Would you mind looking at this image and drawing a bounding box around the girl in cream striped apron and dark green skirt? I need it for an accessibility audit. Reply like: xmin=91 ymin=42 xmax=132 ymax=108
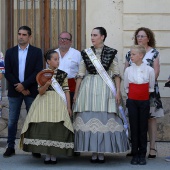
xmin=20 ymin=51 xmax=74 ymax=164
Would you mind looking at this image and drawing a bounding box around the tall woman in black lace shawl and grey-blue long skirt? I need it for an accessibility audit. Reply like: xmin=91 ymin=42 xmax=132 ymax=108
xmin=73 ymin=27 xmax=129 ymax=163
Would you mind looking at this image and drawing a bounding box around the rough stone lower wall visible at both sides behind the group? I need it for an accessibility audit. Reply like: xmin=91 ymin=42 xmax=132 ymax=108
xmin=0 ymin=91 xmax=170 ymax=141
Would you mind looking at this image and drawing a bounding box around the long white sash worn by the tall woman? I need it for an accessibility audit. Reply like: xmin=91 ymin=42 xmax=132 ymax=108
xmin=85 ymin=48 xmax=128 ymax=135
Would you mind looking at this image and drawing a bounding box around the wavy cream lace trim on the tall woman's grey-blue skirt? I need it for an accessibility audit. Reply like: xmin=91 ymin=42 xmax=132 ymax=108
xmin=73 ymin=117 xmax=124 ymax=133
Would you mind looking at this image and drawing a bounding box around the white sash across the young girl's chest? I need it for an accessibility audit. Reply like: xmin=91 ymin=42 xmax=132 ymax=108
xmin=51 ymin=77 xmax=67 ymax=105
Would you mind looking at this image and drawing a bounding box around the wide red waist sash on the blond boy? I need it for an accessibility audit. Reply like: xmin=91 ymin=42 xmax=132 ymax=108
xmin=128 ymin=83 xmax=149 ymax=100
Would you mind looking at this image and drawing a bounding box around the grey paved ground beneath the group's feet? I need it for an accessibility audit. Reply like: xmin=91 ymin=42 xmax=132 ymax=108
xmin=0 ymin=138 xmax=170 ymax=170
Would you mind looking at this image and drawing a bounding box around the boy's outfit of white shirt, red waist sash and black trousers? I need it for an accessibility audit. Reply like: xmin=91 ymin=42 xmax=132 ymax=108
xmin=124 ymin=63 xmax=155 ymax=164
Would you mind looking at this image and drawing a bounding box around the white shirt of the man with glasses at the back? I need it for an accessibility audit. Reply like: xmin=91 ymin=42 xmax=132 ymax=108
xmin=55 ymin=47 xmax=82 ymax=79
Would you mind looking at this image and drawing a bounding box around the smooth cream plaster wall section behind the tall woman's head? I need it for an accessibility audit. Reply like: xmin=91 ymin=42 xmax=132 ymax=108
xmin=86 ymin=0 xmax=123 ymax=66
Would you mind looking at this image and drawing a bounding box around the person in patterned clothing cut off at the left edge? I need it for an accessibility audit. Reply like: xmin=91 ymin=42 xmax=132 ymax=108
xmin=0 ymin=52 xmax=5 ymax=117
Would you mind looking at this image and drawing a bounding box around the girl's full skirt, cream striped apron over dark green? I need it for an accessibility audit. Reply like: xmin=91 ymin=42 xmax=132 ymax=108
xmin=20 ymin=91 xmax=74 ymax=156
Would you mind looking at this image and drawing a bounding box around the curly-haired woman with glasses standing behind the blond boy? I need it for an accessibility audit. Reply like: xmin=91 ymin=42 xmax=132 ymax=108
xmin=125 ymin=27 xmax=164 ymax=158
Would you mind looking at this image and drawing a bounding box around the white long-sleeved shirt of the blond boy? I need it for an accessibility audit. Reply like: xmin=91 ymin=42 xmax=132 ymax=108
xmin=124 ymin=63 xmax=155 ymax=93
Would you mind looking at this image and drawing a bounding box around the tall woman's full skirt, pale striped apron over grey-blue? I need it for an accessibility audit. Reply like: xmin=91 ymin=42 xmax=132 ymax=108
xmin=73 ymin=75 xmax=130 ymax=153
